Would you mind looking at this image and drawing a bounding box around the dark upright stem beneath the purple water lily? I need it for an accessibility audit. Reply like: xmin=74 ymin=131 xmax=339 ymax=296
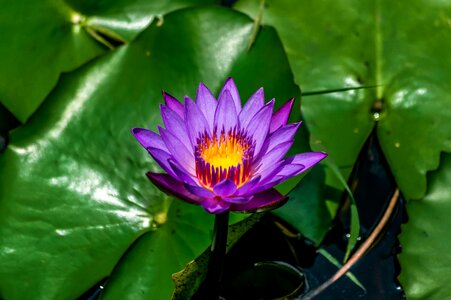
xmin=204 ymin=211 xmax=229 ymax=300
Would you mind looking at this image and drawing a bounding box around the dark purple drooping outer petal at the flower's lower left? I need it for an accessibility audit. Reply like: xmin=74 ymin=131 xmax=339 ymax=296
xmin=146 ymin=172 xmax=202 ymax=204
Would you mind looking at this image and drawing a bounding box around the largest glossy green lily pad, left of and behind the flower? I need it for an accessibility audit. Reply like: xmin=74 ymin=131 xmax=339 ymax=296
xmin=0 ymin=8 xmax=299 ymax=300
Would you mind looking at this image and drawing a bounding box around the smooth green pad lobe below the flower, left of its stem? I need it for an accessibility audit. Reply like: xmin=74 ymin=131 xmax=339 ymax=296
xmin=101 ymin=200 xmax=213 ymax=300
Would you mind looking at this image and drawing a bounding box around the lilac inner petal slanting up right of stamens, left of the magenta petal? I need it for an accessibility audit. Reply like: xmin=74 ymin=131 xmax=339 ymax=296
xmin=246 ymin=100 xmax=274 ymax=156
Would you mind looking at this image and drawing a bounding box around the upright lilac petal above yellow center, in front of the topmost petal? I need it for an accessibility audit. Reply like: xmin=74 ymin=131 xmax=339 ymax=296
xmin=214 ymin=90 xmax=238 ymax=133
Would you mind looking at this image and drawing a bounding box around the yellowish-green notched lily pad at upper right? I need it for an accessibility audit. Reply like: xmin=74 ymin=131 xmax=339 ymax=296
xmin=237 ymin=0 xmax=451 ymax=199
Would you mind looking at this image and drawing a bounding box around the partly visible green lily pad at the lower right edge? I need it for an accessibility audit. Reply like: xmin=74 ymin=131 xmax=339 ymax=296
xmin=399 ymin=154 xmax=451 ymax=300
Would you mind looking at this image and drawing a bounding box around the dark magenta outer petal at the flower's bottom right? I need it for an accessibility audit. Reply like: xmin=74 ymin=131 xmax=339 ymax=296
xmin=230 ymin=189 xmax=288 ymax=212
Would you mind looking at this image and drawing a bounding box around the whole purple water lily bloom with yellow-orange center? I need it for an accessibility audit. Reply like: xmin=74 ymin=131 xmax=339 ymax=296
xmin=132 ymin=78 xmax=327 ymax=214
